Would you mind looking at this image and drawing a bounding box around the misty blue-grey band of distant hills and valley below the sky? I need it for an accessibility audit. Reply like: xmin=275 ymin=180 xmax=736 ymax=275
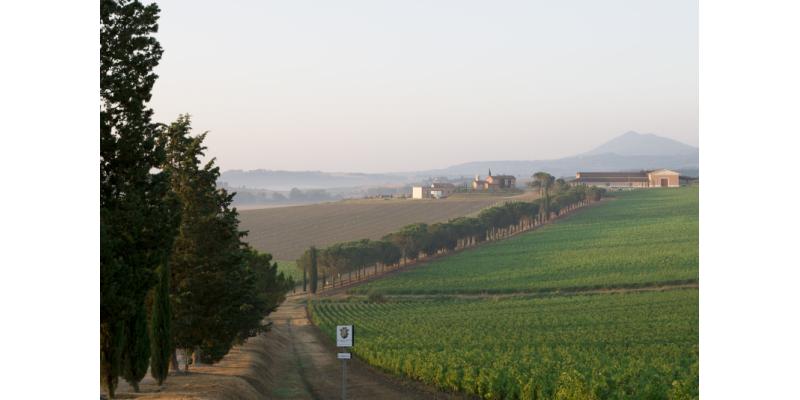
xmin=219 ymin=131 xmax=699 ymax=204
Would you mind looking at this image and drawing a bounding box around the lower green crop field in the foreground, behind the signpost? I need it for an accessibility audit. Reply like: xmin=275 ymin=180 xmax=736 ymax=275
xmin=312 ymin=289 xmax=699 ymax=399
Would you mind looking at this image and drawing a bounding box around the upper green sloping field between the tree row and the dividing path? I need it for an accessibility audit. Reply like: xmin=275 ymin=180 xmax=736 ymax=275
xmin=353 ymin=187 xmax=699 ymax=294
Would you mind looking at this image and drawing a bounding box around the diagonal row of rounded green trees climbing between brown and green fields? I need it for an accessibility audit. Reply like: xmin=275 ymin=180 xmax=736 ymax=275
xmin=297 ymin=177 xmax=605 ymax=293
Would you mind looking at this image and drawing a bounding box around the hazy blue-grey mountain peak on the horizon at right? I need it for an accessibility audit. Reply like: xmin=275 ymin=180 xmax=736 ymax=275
xmin=582 ymin=131 xmax=698 ymax=156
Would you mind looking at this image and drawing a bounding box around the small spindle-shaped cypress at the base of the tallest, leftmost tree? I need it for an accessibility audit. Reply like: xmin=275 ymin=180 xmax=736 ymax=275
xmin=122 ymin=302 xmax=150 ymax=392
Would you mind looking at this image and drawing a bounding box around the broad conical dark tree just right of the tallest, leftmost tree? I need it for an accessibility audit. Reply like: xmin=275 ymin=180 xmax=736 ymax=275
xmin=164 ymin=115 xmax=284 ymax=366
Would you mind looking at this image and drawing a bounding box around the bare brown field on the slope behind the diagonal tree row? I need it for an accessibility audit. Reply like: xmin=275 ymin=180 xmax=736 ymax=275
xmin=239 ymin=193 xmax=535 ymax=260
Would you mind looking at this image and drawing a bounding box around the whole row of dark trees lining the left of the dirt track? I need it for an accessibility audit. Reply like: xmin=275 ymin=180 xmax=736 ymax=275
xmin=100 ymin=0 xmax=294 ymax=398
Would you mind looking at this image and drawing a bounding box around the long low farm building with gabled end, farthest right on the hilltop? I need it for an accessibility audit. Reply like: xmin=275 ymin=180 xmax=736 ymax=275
xmin=573 ymin=169 xmax=680 ymax=189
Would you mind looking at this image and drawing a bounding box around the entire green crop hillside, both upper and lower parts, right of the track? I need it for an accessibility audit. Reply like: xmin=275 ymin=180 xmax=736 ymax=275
xmin=309 ymin=187 xmax=699 ymax=399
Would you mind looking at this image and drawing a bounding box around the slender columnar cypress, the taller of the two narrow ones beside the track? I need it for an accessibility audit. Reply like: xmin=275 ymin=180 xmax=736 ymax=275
xmin=150 ymin=263 xmax=173 ymax=386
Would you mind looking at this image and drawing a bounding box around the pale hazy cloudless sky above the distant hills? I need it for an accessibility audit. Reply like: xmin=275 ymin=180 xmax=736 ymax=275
xmin=152 ymin=0 xmax=698 ymax=172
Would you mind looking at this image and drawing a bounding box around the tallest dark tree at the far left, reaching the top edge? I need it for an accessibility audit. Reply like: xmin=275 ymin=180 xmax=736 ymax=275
xmin=100 ymin=0 xmax=175 ymax=397
